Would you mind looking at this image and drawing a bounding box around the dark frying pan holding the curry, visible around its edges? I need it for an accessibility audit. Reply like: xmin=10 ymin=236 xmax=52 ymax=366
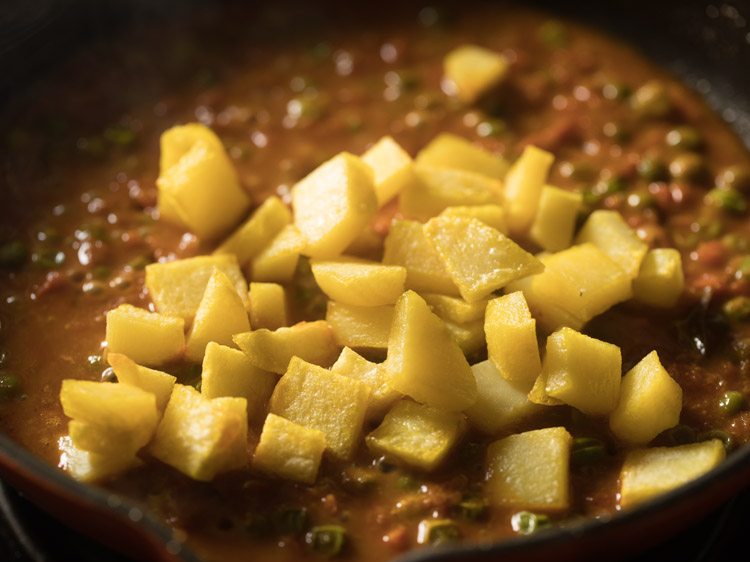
xmin=0 ymin=0 xmax=750 ymax=562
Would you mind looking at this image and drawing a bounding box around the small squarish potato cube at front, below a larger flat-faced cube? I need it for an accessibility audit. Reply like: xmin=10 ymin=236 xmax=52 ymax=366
xmin=252 ymin=414 xmax=326 ymax=484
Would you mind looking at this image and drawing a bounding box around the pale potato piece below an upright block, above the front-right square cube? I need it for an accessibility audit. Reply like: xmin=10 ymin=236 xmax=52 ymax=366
xmin=465 ymin=360 xmax=540 ymax=435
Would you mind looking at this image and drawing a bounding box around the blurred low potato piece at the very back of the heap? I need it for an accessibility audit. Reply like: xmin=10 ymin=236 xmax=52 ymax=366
xmin=415 ymin=133 xmax=510 ymax=180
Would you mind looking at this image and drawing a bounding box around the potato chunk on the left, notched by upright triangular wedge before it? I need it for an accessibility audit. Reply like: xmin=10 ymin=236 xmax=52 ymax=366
xmin=146 ymin=254 xmax=247 ymax=320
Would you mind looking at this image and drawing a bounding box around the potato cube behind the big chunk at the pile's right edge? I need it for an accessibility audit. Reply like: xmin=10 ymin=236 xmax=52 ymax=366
xmin=576 ymin=209 xmax=648 ymax=279
